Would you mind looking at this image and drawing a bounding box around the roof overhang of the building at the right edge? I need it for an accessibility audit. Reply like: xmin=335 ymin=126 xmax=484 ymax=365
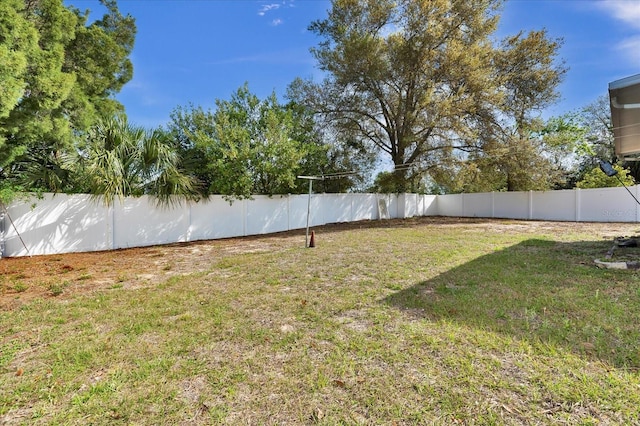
xmin=609 ymin=74 xmax=640 ymax=160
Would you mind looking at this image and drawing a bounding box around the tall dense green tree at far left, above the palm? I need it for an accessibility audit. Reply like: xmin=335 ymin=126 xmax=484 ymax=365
xmin=0 ymin=0 xmax=135 ymax=198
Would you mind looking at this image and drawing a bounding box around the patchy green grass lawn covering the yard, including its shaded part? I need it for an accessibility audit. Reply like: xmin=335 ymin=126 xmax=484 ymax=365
xmin=0 ymin=219 xmax=640 ymax=425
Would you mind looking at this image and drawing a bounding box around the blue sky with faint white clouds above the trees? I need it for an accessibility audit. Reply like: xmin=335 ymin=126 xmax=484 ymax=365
xmin=66 ymin=0 xmax=640 ymax=127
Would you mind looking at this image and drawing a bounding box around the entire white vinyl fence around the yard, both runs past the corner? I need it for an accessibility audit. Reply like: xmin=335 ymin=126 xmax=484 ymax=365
xmin=0 ymin=186 xmax=640 ymax=257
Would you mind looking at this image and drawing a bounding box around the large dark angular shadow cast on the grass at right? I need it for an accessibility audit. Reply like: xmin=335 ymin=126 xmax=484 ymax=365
xmin=385 ymin=239 xmax=640 ymax=369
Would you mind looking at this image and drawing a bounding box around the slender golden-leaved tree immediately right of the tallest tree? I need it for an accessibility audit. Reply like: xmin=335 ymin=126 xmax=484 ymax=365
xmin=472 ymin=31 xmax=573 ymax=191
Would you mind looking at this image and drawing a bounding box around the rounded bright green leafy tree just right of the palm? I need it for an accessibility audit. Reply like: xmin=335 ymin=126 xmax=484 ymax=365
xmin=169 ymin=84 xmax=307 ymax=199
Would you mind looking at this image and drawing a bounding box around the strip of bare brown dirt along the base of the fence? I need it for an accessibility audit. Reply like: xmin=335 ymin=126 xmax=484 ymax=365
xmin=0 ymin=217 xmax=639 ymax=310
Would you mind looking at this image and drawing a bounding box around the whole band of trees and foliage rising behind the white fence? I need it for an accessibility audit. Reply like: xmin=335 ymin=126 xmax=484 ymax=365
xmin=0 ymin=0 xmax=640 ymax=203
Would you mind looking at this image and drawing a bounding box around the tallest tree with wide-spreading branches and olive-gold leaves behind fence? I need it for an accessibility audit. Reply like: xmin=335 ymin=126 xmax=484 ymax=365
xmin=306 ymin=0 xmax=557 ymax=191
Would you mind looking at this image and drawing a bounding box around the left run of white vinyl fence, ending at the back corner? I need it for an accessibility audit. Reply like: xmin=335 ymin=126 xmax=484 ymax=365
xmin=0 ymin=194 xmax=437 ymax=257
